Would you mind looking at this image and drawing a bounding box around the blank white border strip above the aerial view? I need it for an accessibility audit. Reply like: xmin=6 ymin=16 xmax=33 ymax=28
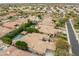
xmin=0 ymin=0 xmax=79 ymax=3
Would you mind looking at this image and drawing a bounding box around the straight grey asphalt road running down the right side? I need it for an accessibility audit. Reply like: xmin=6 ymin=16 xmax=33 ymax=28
xmin=67 ymin=21 xmax=79 ymax=56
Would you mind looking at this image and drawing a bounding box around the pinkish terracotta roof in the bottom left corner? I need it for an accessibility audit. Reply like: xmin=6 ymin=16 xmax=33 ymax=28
xmin=0 ymin=46 xmax=32 ymax=56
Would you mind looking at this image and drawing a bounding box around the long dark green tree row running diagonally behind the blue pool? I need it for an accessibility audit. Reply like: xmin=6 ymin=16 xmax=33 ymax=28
xmin=1 ymin=22 xmax=39 ymax=44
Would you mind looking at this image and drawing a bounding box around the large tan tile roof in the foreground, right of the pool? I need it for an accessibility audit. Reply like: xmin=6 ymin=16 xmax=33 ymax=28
xmin=21 ymin=33 xmax=55 ymax=54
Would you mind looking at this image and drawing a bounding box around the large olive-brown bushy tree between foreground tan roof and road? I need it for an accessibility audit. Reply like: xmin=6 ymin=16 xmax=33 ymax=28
xmin=55 ymin=39 xmax=69 ymax=56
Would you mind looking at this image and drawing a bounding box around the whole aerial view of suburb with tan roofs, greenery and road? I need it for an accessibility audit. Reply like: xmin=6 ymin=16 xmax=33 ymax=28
xmin=0 ymin=3 xmax=79 ymax=56
